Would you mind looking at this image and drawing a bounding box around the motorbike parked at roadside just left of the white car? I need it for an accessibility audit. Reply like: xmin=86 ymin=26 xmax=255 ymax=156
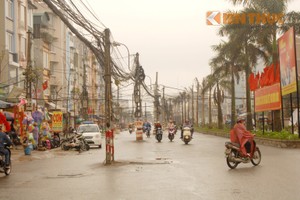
xmin=60 ymin=133 xmax=90 ymax=153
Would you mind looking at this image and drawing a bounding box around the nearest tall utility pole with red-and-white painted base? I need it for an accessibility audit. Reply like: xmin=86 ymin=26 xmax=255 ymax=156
xmin=104 ymin=29 xmax=113 ymax=164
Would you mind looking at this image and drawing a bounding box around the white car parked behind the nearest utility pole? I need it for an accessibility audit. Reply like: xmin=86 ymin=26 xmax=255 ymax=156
xmin=77 ymin=124 xmax=102 ymax=148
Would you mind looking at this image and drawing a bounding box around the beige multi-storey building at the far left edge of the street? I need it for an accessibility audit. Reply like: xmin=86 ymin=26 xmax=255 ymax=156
xmin=0 ymin=0 xmax=36 ymax=102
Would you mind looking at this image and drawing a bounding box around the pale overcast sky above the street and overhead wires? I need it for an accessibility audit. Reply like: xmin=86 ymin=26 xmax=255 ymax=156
xmin=84 ymin=0 xmax=300 ymax=96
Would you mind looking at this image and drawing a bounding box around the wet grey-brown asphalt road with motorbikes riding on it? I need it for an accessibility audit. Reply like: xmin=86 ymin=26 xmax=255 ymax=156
xmin=0 ymin=132 xmax=300 ymax=200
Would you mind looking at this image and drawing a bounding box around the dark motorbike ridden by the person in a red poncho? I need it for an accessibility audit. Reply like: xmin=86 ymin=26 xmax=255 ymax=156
xmin=225 ymin=142 xmax=261 ymax=169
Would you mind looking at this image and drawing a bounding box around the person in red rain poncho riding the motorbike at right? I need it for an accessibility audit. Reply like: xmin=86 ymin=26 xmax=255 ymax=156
xmin=230 ymin=117 xmax=255 ymax=157
